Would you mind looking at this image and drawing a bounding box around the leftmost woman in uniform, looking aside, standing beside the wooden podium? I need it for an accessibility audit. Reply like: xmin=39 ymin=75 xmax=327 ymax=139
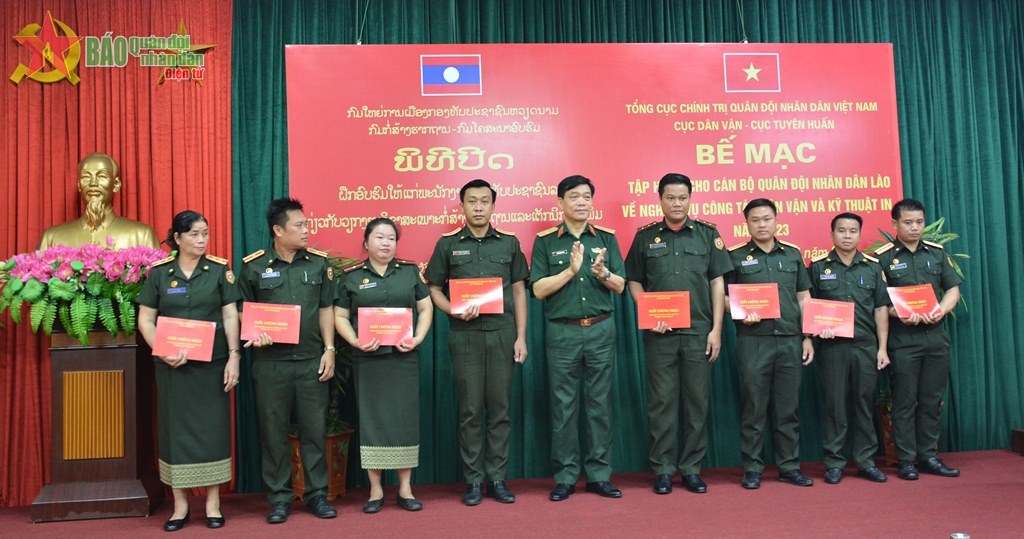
xmin=136 ymin=210 xmax=242 ymax=532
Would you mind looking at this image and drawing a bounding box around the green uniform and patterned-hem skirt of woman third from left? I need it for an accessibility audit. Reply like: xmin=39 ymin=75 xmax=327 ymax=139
xmin=335 ymin=260 xmax=430 ymax=469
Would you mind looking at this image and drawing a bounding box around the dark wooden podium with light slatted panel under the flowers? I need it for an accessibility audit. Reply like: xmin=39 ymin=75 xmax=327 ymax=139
xmin=32 ymin=331 xmax=164 ymax=523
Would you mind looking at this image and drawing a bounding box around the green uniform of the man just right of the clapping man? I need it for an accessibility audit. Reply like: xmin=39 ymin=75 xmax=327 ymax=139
xmin=626 ymin=218 xmax=732 ymax=475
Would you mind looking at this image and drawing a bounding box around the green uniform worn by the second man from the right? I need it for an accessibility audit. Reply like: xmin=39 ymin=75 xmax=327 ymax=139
xmin=808 ymin=249 xmax=889 ymax=470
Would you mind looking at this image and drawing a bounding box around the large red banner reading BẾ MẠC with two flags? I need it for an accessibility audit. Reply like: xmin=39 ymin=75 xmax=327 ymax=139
xmin=286 ymin=44 xmax=902 ymax=261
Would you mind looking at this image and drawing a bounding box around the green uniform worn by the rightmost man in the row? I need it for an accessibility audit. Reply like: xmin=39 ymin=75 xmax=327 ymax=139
xmin=874 ymin=240 xmax=961 ymax=462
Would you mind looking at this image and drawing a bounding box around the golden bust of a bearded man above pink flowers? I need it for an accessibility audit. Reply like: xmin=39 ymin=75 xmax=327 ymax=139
xmin=39 ymin=153 xmax=160 ymax=249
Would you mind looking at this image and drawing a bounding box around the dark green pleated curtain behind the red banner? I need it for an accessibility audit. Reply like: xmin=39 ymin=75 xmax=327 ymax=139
xmin=232 ymin=0 xmax=1024 ymax=491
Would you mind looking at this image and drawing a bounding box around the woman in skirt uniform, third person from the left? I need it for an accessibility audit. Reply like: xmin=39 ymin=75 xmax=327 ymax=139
xmin=334 ymin=217 xmax=434 ymax=513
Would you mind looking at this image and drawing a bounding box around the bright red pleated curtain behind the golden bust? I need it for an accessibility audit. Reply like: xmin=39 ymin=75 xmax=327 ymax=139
xmin=0 ymin=0 xmax=231 ymax=506
